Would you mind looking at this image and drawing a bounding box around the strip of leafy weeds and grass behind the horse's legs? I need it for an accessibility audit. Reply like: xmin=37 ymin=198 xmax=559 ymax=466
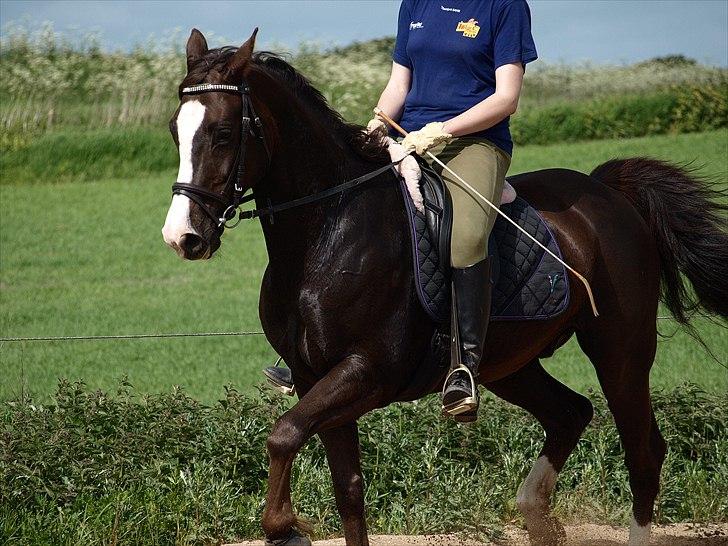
xmin=0 ymin=382 xmax=728 ymax=544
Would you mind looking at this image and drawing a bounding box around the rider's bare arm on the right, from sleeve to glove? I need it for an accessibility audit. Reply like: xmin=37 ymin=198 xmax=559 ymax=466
xmin=443 ymin=63 xmax=523 ymax=137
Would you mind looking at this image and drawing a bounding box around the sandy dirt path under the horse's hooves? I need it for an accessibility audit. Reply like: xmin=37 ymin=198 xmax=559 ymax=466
xmin=228 ymin=523 xmax=728 ymax=546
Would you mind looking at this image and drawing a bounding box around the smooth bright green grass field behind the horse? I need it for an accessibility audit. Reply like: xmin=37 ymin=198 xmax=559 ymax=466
xmin=0 ymin=126 xmax=728 ymax=402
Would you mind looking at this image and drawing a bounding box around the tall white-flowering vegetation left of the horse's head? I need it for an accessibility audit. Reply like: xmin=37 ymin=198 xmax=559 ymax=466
xmin=0 ymin=25 xmax=185 ymax=137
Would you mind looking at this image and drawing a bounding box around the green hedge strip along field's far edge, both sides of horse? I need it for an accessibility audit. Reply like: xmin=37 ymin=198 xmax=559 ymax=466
xmin=0 ymin=83 xmax=728 ymax=183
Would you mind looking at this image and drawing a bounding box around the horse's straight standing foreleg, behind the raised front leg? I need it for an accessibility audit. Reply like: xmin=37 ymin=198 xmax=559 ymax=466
xmin=319 ymin=423 xmax=369 ymax=546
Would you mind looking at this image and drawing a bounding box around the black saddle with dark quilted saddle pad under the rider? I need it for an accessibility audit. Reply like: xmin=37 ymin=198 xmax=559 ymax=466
xmin=400 ymin=156 xmax=569 ymax=323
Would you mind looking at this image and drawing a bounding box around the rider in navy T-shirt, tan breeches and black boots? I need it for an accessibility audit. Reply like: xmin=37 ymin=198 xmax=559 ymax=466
xmin=266 ymin=0 xmax=537 ymax=422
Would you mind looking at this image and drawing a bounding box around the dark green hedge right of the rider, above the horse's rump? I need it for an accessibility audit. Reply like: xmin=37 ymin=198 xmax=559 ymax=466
xmin=511 ymin=84 xmax=728 ymax=144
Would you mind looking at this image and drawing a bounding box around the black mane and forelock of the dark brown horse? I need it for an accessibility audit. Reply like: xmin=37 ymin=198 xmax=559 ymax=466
xmin=180 ymin=46 xmax=388 ymax=161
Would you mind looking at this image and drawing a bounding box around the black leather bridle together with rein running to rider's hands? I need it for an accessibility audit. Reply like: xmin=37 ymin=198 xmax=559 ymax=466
xmin=172 ymin=82 xmax=402 ymax=231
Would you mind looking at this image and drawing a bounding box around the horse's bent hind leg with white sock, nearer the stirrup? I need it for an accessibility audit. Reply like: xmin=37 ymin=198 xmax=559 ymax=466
xmin=485 ymin=360 xmax=593 ymax=546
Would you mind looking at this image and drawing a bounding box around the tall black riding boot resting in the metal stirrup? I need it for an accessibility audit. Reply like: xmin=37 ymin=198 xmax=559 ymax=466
xmin=442 ymin=257 xmax=491 ymax=423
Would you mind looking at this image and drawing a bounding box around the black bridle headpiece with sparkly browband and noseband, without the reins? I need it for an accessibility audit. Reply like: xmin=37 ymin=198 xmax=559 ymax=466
xmin=172 ymin=82 xmax=270 ymax=230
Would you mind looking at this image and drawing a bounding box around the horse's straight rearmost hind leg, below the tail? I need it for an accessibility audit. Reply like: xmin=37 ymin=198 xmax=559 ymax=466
xmin=577 ymin=317 xmax=666 ymax=546
